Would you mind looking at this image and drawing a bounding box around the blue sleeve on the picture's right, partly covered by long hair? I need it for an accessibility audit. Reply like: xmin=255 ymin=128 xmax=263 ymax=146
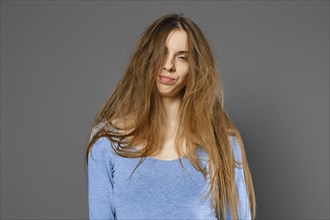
xmin=227 ymin=137 xmax=251 ymax=220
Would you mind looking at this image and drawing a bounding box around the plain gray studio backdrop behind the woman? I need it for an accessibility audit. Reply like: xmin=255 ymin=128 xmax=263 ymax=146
xmin=1 ymin=1 xmax=329 ymax=219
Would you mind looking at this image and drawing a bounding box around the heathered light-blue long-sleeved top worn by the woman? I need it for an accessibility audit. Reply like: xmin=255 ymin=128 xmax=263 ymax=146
xmin=88 ymin=125 xmax=251 ymax=219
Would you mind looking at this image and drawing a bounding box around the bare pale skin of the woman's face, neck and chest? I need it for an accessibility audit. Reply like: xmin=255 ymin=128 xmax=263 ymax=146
xmin=112 ymin=29 xmax=189 ymax=160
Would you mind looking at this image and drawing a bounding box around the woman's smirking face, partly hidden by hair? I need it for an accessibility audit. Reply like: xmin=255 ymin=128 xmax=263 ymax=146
xmin=157 ymin=30 xmax=189 ymax=98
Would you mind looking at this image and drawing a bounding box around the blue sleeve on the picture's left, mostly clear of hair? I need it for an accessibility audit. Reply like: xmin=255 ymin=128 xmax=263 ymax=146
xmin=88 ymin=137 xmax=116 ymax=220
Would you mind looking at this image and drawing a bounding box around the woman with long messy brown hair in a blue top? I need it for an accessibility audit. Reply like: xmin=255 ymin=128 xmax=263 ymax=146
xmin=85 ymin=13 xmax=256 ymax=219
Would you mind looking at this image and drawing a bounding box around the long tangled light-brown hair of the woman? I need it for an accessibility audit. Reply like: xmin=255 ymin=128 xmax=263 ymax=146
xmin=85 ymin=12 xmax=256 ymax=219
